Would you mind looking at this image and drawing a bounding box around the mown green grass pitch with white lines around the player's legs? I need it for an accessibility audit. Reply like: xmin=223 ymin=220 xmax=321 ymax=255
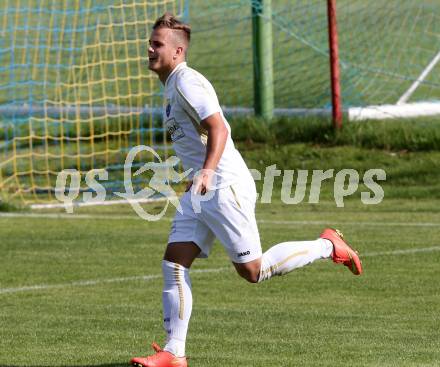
xmin=0 ymin=145 xmax=440 ymax=367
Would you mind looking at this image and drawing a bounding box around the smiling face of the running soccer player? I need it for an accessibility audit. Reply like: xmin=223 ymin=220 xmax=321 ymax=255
xmin=148 ymin=28 xmax=177 ymax=76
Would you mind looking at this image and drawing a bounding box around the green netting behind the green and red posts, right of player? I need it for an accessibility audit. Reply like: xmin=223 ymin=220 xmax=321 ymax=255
xmin=189 ymin=0 xmax=440 ymax=118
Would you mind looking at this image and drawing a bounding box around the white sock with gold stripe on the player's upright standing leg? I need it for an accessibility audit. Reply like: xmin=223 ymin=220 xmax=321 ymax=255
xmin=162 ymin=260 xmax=192 ymax=357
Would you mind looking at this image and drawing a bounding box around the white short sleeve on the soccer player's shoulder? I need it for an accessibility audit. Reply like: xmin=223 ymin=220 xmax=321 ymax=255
xmin=176 ymin=73 xmax=221 ymax=124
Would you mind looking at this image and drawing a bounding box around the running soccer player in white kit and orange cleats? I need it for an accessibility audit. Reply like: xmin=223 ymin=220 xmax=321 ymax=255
xmin=131 ymin=13 xmax=362 ymax=367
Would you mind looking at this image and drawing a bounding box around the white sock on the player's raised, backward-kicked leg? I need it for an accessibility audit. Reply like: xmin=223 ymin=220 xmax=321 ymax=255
xmin=258 ymin=238 xmax=333 ymax=282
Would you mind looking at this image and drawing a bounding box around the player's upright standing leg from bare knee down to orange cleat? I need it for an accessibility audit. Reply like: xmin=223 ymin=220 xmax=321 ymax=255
xmin=131 ymin=242 xmax=200 ymax=367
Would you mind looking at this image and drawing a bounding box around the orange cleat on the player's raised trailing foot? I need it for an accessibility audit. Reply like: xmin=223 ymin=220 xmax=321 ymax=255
xmin=319 ymin=228 xmax=362 ymax=275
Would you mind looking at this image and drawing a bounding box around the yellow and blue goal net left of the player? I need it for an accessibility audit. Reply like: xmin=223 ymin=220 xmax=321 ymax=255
xmin=0 ymin=0 xmax=185 ymax=204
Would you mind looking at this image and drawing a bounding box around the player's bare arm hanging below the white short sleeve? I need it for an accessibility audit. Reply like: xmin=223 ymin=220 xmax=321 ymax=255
xmin=193 ymin=112 xmax=229 ymax=195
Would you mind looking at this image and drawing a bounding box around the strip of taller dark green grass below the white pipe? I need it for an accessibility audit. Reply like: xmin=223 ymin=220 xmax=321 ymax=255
xmin=230 ymin=117 xmax=440 ymax=151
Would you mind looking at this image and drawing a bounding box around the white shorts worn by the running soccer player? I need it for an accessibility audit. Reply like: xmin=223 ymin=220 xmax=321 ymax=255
xmin=168 ymin=182 xmax=262 ymax=263
